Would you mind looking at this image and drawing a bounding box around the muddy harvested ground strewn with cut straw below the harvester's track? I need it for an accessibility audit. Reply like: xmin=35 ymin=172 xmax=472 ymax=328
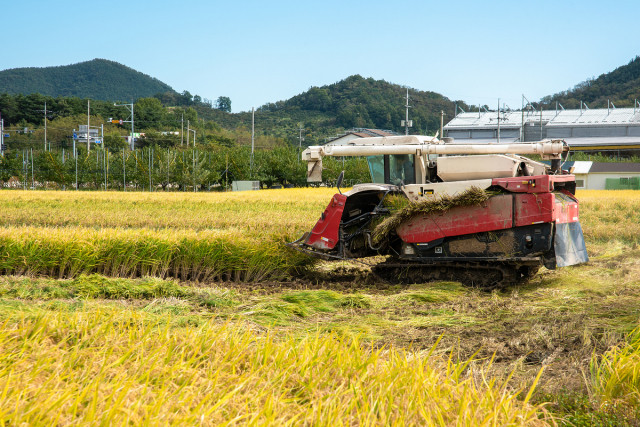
xmin=214 ymin=245 xmax=640 ymax=422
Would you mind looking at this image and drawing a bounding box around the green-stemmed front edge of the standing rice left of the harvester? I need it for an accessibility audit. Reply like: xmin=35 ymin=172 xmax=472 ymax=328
xmin=0 ymin=227 xmax=312 ymax=282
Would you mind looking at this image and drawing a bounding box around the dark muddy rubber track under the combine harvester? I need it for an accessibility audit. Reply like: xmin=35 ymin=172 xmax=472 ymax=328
xmin=372 ymin=260 xmax=539 ymax=290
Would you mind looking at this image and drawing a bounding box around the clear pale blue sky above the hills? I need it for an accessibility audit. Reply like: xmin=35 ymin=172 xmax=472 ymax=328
xmin=0 ymin=0 xmax=640 ymax=112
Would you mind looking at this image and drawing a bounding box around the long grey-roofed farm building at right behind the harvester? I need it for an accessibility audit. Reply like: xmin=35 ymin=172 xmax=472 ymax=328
xmin=444 ymin=102 xmax=640 ymax=153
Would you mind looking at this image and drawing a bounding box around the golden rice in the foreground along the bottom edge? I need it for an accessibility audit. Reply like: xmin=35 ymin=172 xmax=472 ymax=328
xmin=0 ymin=310 xmax=553 ymax=426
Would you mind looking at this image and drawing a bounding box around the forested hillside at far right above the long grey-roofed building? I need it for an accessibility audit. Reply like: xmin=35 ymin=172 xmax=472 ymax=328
xmin=541 ymin=56 xmax=640 ymax=108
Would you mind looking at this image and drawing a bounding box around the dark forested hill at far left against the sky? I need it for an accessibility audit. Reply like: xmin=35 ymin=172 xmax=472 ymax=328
xmin=0 ymin=59 xmax=173 ymax=101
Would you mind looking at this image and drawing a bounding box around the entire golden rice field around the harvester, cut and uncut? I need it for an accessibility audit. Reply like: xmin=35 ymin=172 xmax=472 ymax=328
xmin=0 ymin=189 xmax=640 ymax=426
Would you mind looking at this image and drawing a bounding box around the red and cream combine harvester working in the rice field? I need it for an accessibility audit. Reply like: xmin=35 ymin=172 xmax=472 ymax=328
xmin=290 ymin=135 xmax=588 ymax=289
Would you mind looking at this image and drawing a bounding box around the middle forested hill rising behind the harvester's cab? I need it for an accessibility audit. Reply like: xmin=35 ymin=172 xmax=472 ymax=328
xmin=189 ymin=75 xmax=468 ymax=145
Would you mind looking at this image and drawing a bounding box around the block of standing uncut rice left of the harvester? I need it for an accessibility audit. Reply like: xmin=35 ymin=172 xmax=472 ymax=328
xmin=0 ymin=189 xmax=332 ymax=282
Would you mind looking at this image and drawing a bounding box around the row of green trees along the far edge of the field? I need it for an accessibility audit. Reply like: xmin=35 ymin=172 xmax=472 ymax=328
xmin=0 ymin=146 xmax=370 ymax=191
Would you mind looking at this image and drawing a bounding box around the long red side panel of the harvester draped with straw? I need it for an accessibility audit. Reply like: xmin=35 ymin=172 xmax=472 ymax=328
xmin=396 ymin=194 xmax=513 ymax=243
